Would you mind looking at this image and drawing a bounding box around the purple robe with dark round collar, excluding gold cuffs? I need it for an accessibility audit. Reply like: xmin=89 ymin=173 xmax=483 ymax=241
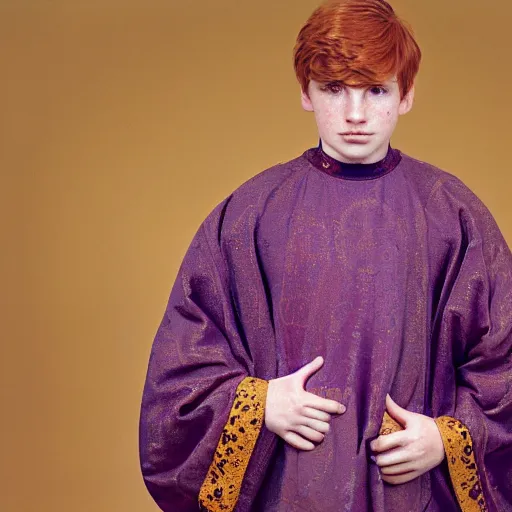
xmin=140 ymin=148 xmax=512 ymax=512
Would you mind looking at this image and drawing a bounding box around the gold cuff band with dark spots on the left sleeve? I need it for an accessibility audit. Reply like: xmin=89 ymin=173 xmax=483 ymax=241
xmin=199 ymin=377 xmax=268 ymax=512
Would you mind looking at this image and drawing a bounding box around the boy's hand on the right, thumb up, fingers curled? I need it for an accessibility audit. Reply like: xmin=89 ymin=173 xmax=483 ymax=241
xmin=370 ymin=395 xmax=445 ymax=485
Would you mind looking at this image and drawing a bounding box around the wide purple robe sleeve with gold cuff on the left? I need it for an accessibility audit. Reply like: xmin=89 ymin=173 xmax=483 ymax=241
xmin=139 ymin=203 xmax=273 ymax=512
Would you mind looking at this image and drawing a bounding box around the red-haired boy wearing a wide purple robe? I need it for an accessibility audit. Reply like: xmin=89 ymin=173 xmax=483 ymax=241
xmin=141 ymin=0 xmax=512 ymax=512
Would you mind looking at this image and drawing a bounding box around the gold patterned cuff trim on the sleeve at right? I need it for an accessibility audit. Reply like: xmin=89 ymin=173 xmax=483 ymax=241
xmin=435 ymin=416 xmax=488 ymax=512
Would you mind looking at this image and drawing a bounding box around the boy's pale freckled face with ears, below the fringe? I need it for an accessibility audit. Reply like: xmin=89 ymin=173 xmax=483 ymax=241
xmin=301 ymin=78 xmax=414 ymax=164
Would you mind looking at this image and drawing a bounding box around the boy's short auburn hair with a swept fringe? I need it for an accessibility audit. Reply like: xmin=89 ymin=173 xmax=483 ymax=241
xmin=293 ymin=0 xmax=421 ymax=98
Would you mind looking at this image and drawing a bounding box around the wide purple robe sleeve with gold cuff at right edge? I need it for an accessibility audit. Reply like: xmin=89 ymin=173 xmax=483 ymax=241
xmin=429 ymin=179 xmax=512 ymax=512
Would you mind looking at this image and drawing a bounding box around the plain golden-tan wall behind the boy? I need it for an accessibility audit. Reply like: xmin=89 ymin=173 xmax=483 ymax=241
xmin=0 ymin=0 xmax=512 ymax=512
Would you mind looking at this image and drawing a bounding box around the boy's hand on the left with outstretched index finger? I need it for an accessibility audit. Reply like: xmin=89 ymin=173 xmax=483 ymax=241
xmin=265 ymin=357 xmax=346 ymax=450
